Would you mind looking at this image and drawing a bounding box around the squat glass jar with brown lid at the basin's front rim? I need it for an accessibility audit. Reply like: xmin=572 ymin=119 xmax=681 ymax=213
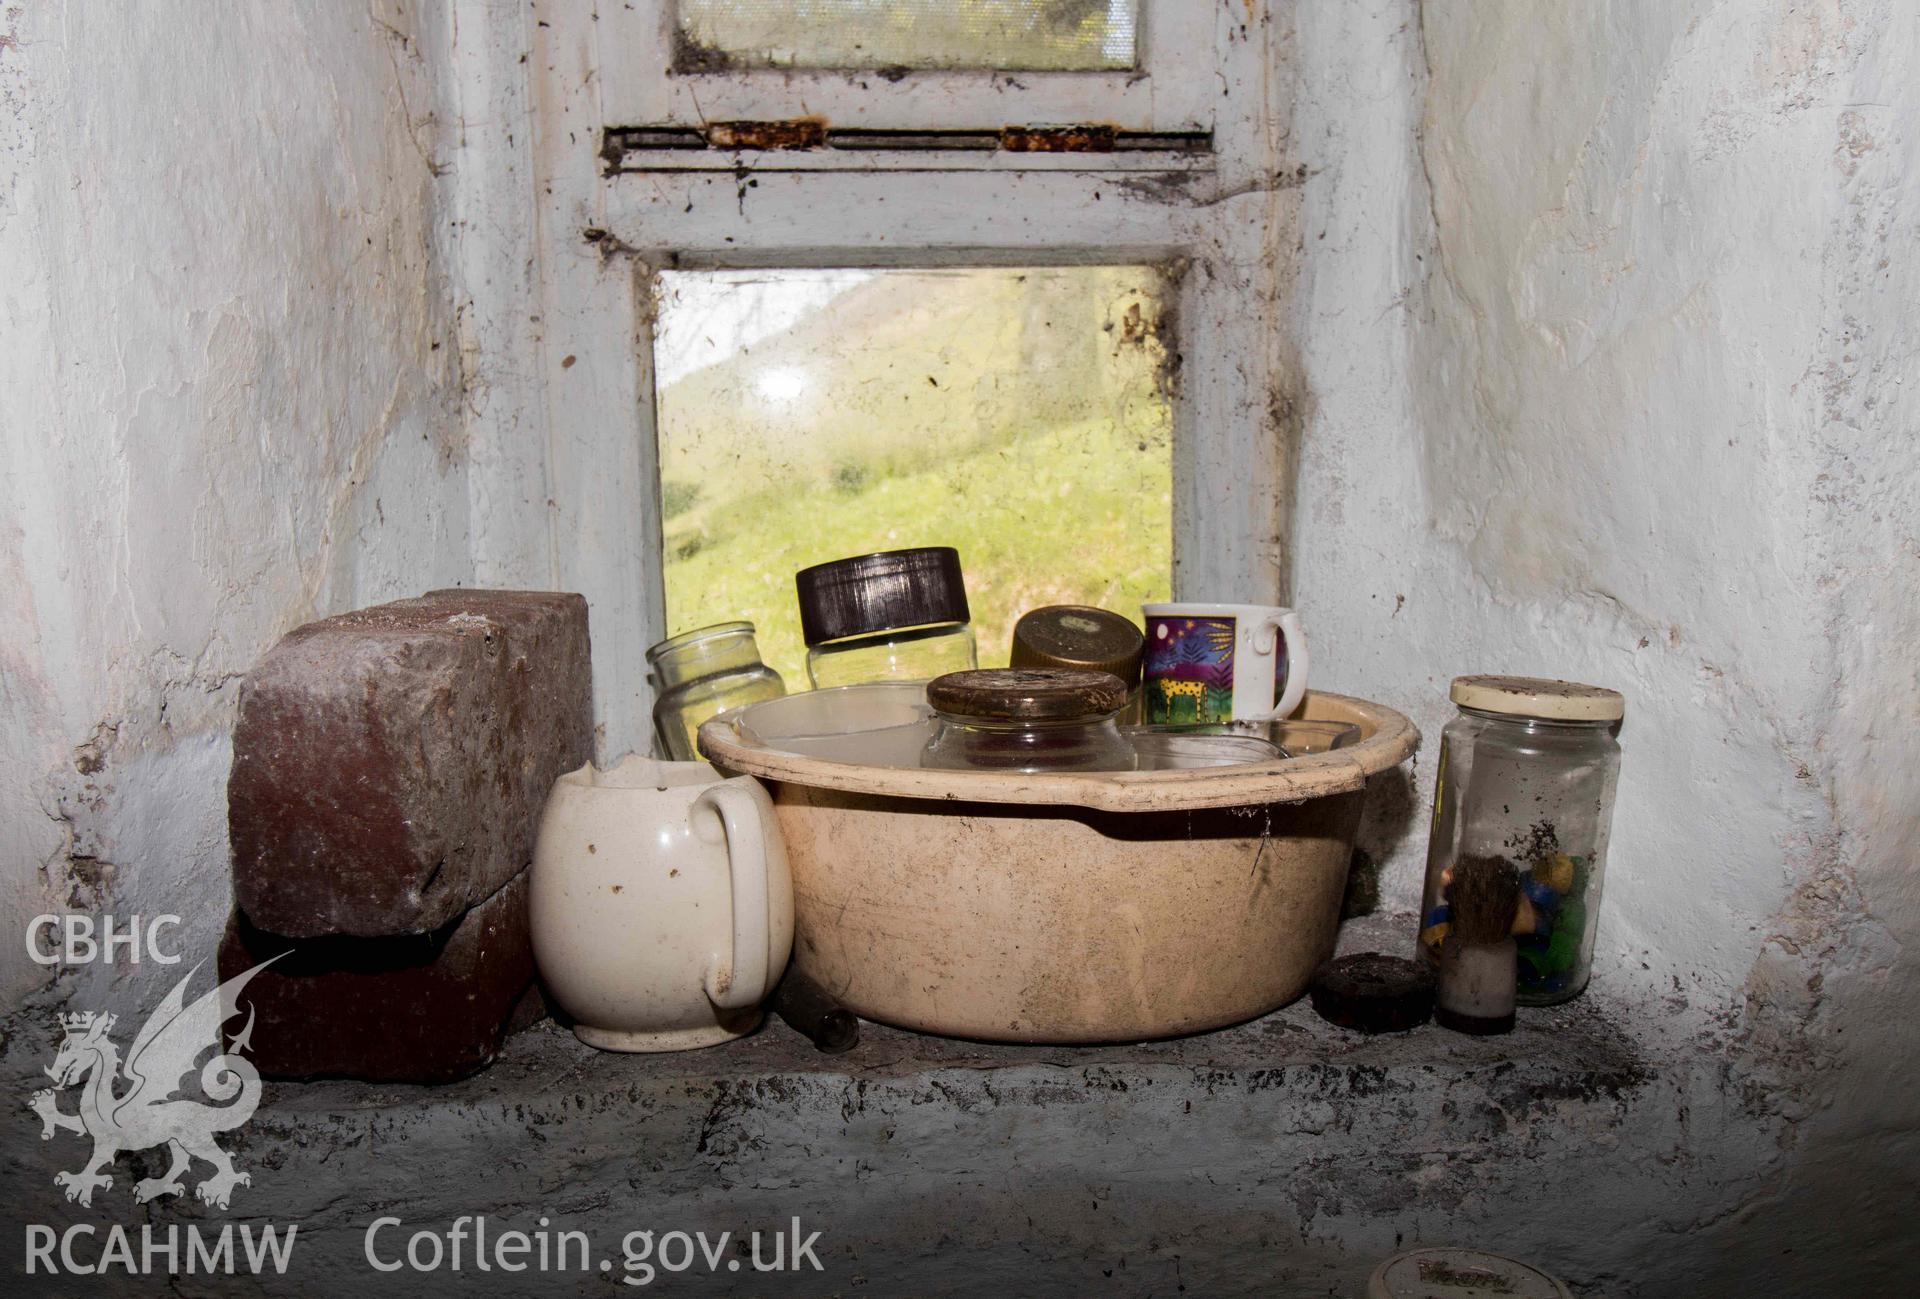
xmin=920 ymin=668 xmax=1135 ymax=771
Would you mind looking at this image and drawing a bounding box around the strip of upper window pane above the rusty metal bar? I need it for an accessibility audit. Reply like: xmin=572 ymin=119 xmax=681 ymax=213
xmin=674 ymin=0 xmax=1136 ymax=71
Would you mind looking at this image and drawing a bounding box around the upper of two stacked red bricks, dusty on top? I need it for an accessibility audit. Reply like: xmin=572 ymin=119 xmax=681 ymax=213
xmin=227 ymin=591 xmax=593 ymax=938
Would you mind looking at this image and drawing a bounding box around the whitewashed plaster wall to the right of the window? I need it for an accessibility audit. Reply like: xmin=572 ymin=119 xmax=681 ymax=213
xmin=1294 ymin=0 xmax=1920 ymax=1293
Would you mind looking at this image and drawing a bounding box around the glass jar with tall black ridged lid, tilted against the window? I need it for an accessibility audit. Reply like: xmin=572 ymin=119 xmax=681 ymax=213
xmin=793 ymin=545 xmax=979 ymax=691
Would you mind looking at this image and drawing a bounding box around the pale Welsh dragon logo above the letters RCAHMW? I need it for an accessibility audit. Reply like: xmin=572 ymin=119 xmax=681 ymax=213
xmin=29 ymin=961 xmax=271 ymax=1209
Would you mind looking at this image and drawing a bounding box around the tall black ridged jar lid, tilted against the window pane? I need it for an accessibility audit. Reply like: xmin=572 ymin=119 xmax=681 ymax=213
xmin=793 ymin=545 xmax=972 ymax=649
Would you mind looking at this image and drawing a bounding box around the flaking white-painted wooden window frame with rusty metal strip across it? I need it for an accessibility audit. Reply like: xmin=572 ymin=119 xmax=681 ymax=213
xmin=495 ymin=0 xmax=1300 ymax=756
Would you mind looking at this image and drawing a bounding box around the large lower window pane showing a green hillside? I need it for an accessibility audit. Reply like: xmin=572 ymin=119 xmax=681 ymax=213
xmin=655 ymin=267 xmax=1173 ymax=689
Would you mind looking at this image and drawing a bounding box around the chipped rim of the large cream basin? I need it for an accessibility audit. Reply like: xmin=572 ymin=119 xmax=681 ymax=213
xmin=699 ymin=691 xmax=1421 ymax=812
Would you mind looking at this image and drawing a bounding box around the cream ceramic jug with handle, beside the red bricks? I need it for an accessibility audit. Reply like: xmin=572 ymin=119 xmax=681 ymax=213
xmin=528 ymin=756 xmax=793 ymax=1051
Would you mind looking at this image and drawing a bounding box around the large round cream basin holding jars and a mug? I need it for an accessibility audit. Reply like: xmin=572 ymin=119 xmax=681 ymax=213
xmin=701 ymin=683 xmax=1419 ymax=1042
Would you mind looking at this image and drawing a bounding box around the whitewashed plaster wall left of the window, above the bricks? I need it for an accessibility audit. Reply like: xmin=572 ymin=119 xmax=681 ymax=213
xmin=0 ymin=0 xmax=472 ymax=1004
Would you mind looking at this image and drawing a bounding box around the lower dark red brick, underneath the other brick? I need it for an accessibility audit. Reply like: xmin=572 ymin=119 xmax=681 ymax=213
xmin=219 ymin=871 xmax=534 ymax=1082
